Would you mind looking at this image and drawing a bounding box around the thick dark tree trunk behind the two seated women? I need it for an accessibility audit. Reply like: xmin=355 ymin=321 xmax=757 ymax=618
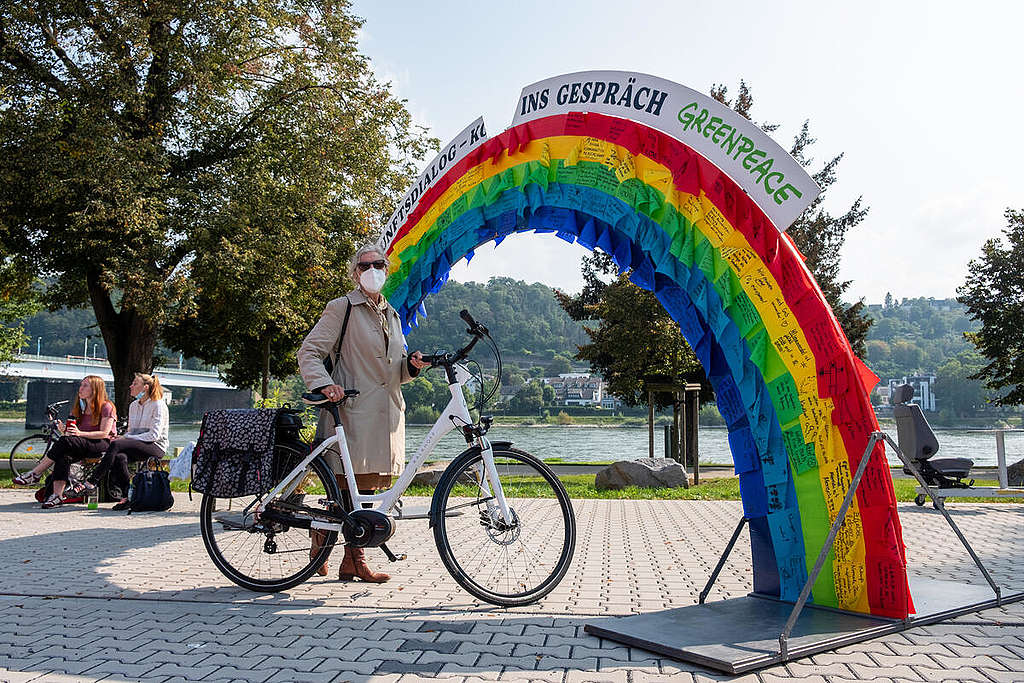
xmin=86 ymin=273 xmax=157 ymax=416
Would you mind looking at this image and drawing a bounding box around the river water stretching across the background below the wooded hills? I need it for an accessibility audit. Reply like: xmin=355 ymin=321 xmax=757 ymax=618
xmin=0 ymin=422 xmax=1024 ymax=465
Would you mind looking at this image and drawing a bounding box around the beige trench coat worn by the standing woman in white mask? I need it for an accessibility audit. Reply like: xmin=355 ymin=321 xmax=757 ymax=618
xmin=298 ymin=288 xmax=418 ymax=475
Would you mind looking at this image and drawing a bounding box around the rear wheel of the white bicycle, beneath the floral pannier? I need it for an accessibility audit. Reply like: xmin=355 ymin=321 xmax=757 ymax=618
xmin=200 ymin=446 xmax=341 ymax=593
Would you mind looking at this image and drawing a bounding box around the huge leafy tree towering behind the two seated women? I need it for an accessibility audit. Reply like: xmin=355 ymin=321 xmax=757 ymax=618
xmin=0 ymin=0 xmax=432 ymax=410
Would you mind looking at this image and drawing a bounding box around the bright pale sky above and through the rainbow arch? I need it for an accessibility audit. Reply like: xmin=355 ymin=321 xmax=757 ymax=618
xmin=354 ymin=0 xmax=1024 ymax=303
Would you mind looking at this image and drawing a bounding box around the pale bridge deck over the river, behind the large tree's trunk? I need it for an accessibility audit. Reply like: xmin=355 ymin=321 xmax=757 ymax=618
xmin=0 ymin=354 xmax=234 ymax=389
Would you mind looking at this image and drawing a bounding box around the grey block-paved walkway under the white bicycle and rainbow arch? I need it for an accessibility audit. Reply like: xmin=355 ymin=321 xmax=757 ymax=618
xmin=0 ymin=490 xmax=1024 ymax=683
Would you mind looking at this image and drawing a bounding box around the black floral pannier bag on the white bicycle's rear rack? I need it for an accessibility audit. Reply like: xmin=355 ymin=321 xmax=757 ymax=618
xmin=190 ymin=409 xmax=278 ymax=498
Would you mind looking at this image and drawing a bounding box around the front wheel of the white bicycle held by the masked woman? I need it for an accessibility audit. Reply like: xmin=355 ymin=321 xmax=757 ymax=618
xmin=434 ymin=447 xmax=575 ymax=607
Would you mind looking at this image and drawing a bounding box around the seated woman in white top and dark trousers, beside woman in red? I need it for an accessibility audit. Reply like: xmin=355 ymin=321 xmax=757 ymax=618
xmin=74 ymin=373 xmax=167 ymax=510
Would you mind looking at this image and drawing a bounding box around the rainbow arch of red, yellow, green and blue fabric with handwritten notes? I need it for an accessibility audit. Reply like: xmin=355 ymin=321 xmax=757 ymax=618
xmin=385 ymin=105 xmax=913 ymax=618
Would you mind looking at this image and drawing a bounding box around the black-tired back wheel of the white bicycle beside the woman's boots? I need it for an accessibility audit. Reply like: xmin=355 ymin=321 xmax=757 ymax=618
xmin=200 ymin=446 xmax=341 ymax=593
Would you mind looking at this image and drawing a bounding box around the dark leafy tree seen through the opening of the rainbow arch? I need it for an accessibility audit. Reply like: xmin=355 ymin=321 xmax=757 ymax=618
xmin=555 ymin=251 xmax=710 ymax=407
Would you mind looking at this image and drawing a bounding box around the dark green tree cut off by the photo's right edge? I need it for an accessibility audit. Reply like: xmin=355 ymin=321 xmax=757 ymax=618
xmin=956 ymin=209 xmax=1024 ymax=405
